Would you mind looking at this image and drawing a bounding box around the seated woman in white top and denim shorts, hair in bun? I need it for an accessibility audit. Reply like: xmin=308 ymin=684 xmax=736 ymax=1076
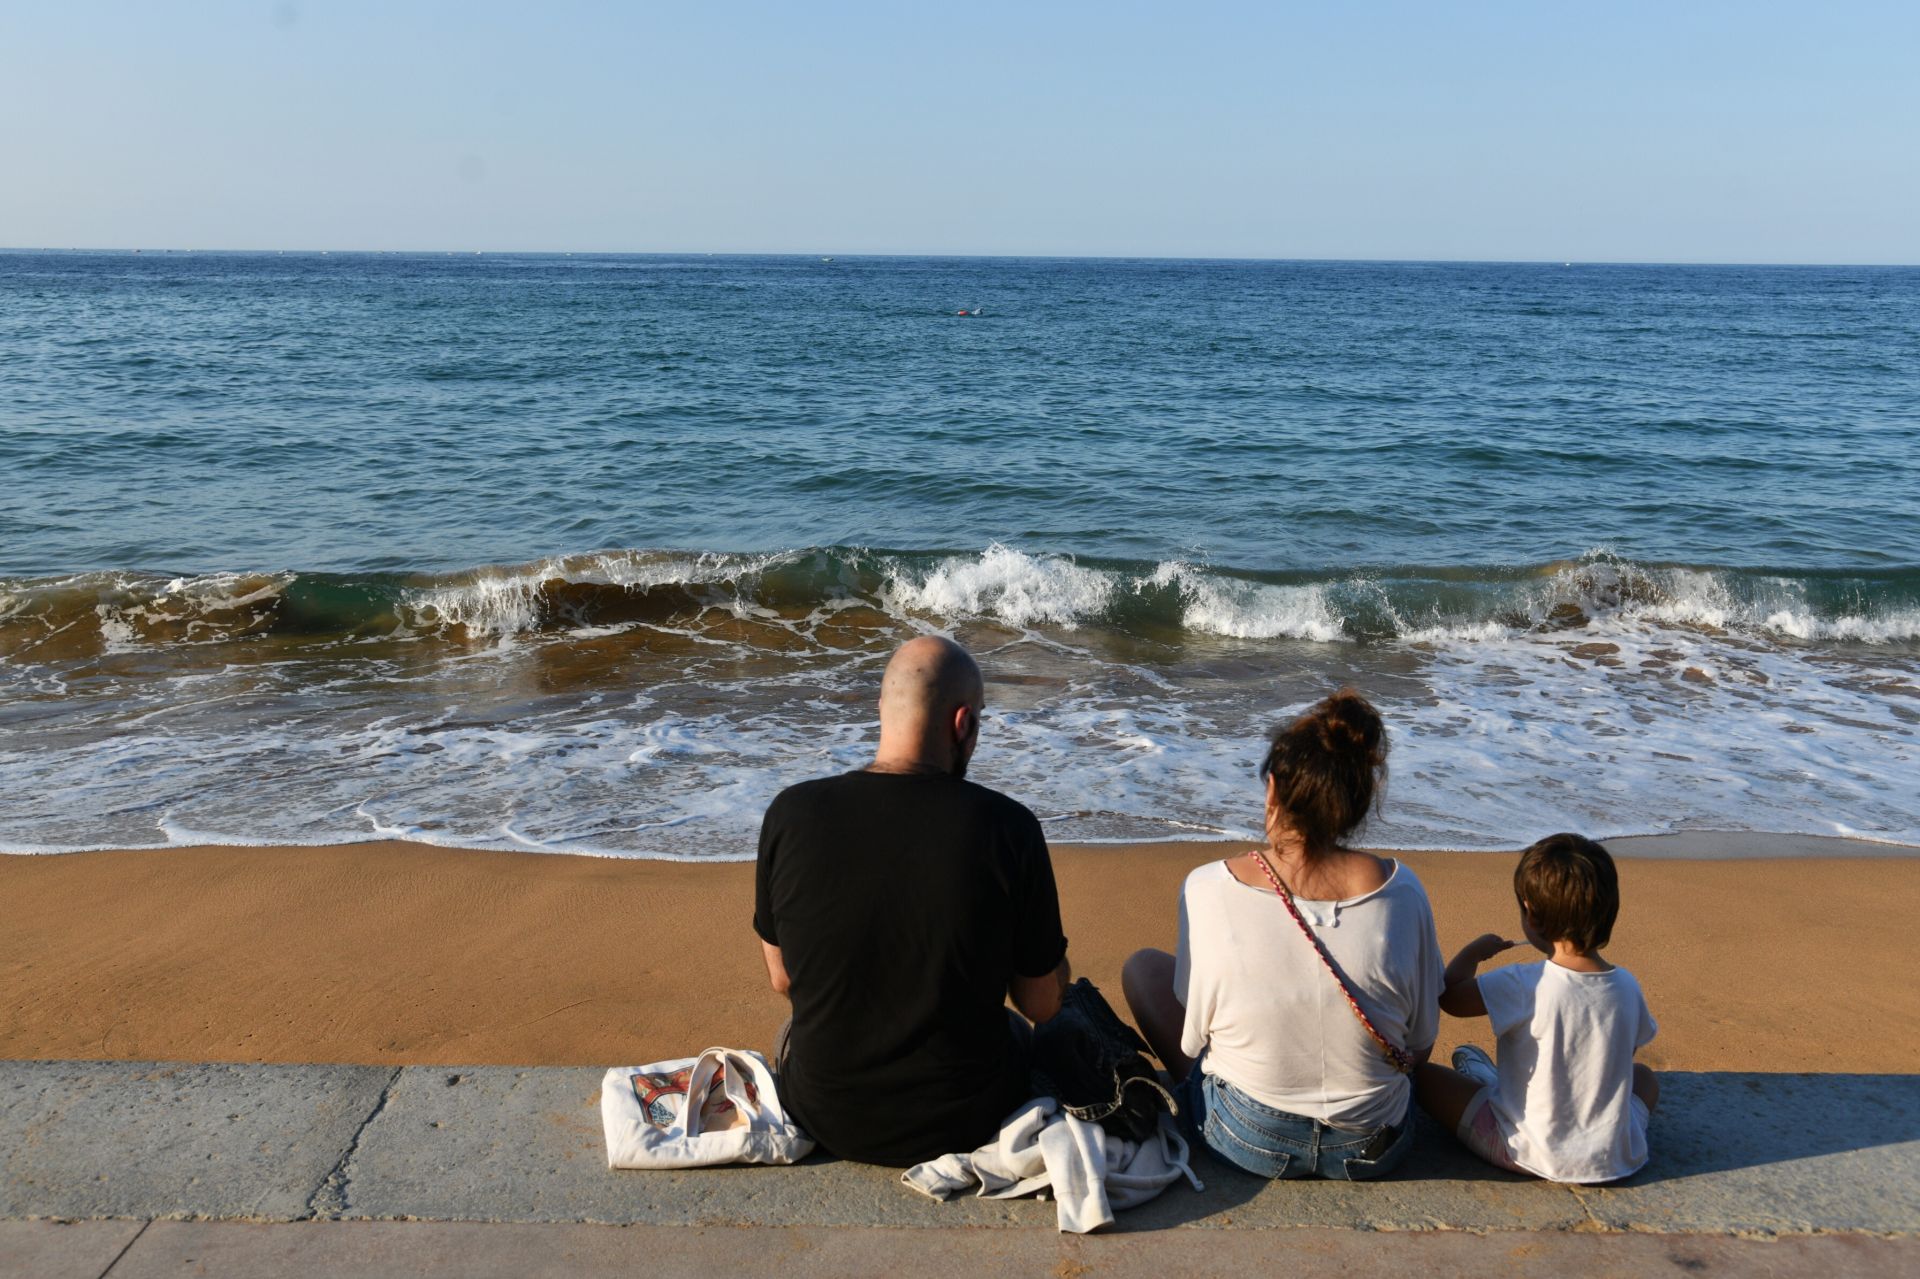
xmin=1121 ymin=689 xmax=1444 ymax=1181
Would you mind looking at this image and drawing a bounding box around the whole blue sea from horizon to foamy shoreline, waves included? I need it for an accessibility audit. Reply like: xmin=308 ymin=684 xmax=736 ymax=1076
xmin=0 ymin=250 xmax=1920 ymax=858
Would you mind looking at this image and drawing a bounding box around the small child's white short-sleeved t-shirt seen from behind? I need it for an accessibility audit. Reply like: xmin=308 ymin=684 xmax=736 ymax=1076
xmin=1480 ymin=960 xmax=1657 ymax=1181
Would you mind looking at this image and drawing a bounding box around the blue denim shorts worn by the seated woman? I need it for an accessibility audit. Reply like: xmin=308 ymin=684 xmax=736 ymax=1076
xmin=1177 ymin=1062 xmax=1413 ymax=1181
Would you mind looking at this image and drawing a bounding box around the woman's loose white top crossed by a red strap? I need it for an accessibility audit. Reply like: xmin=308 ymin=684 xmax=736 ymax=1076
xmin=1173 ymin=862 xmax=1446 ymax=1129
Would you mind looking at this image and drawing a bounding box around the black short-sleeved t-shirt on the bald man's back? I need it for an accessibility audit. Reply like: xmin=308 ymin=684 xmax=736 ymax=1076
xmin=753 ymin=772 xmax=1068 ymax=1166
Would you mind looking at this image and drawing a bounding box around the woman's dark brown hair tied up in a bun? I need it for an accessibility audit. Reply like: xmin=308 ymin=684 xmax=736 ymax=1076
xmin=1260 ymin=688 xmax=1386 ymax=855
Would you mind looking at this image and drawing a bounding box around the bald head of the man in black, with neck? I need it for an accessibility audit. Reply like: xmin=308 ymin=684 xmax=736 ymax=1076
xmin=874 ymin=636 xmax=987 ymax=778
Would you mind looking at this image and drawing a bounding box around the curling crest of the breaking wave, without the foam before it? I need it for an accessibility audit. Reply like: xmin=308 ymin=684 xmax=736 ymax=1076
xmin=0 ymin=543 xmax=1920 ymax=661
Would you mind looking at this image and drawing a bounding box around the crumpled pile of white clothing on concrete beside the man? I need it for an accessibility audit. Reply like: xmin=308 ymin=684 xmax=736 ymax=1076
xmin=900 ymin=1097 xmax=1206 ymax=1235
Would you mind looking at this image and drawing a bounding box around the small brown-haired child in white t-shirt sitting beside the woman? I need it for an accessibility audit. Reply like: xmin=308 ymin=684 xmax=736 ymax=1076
xmin=1413 ymin=835 xmax=1659 ymax=1181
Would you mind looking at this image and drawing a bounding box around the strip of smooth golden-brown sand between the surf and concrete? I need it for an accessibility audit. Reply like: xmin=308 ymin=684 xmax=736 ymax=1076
xmin=0 ymin=835 xmax=1920 ymax=1072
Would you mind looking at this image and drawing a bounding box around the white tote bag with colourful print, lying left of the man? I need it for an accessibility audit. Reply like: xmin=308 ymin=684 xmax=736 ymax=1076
xmin=601 ymin=1049 xmax=814 ymax=1168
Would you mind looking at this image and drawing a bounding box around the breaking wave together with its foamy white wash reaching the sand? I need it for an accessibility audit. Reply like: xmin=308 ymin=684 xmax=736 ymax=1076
xmin=11 ymin=545 xmax=1920 ymax=857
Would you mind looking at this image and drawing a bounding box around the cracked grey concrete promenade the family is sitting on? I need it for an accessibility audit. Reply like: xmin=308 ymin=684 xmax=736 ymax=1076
xmin=0 ymin=1062 xmax=1920 ymax=1279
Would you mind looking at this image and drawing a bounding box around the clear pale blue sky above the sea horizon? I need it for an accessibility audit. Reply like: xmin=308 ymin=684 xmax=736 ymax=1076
xmin=0 ymin=0 xmax=1920 ymax=263
